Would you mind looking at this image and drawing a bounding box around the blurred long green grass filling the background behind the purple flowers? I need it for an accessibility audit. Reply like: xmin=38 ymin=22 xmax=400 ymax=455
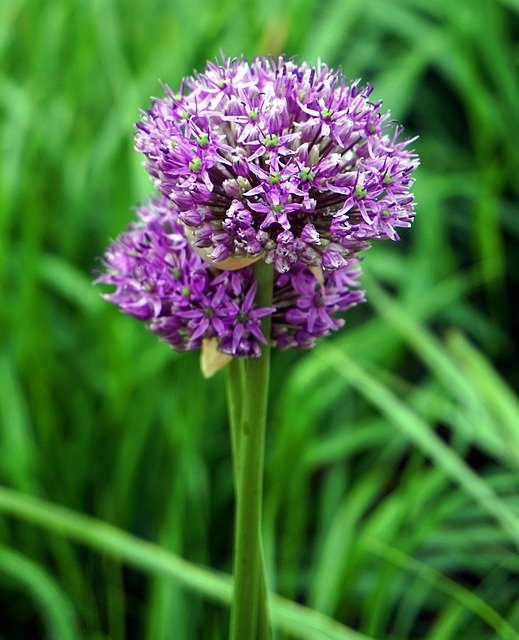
xmin=0 ymin=0 xmax=519 ymax=640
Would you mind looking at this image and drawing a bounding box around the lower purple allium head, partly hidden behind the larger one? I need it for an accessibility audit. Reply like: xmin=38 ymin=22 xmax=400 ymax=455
xmin=97 ymin=197 xmax=364 ymax=357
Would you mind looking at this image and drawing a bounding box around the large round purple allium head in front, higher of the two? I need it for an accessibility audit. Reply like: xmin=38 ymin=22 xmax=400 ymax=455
xmin=136 ymin=57 xmax=418 ymax=273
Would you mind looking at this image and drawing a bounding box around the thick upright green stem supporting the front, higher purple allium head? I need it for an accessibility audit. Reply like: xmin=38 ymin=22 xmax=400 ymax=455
xmin=229 ymin=261 xmax=273 ymax=640
